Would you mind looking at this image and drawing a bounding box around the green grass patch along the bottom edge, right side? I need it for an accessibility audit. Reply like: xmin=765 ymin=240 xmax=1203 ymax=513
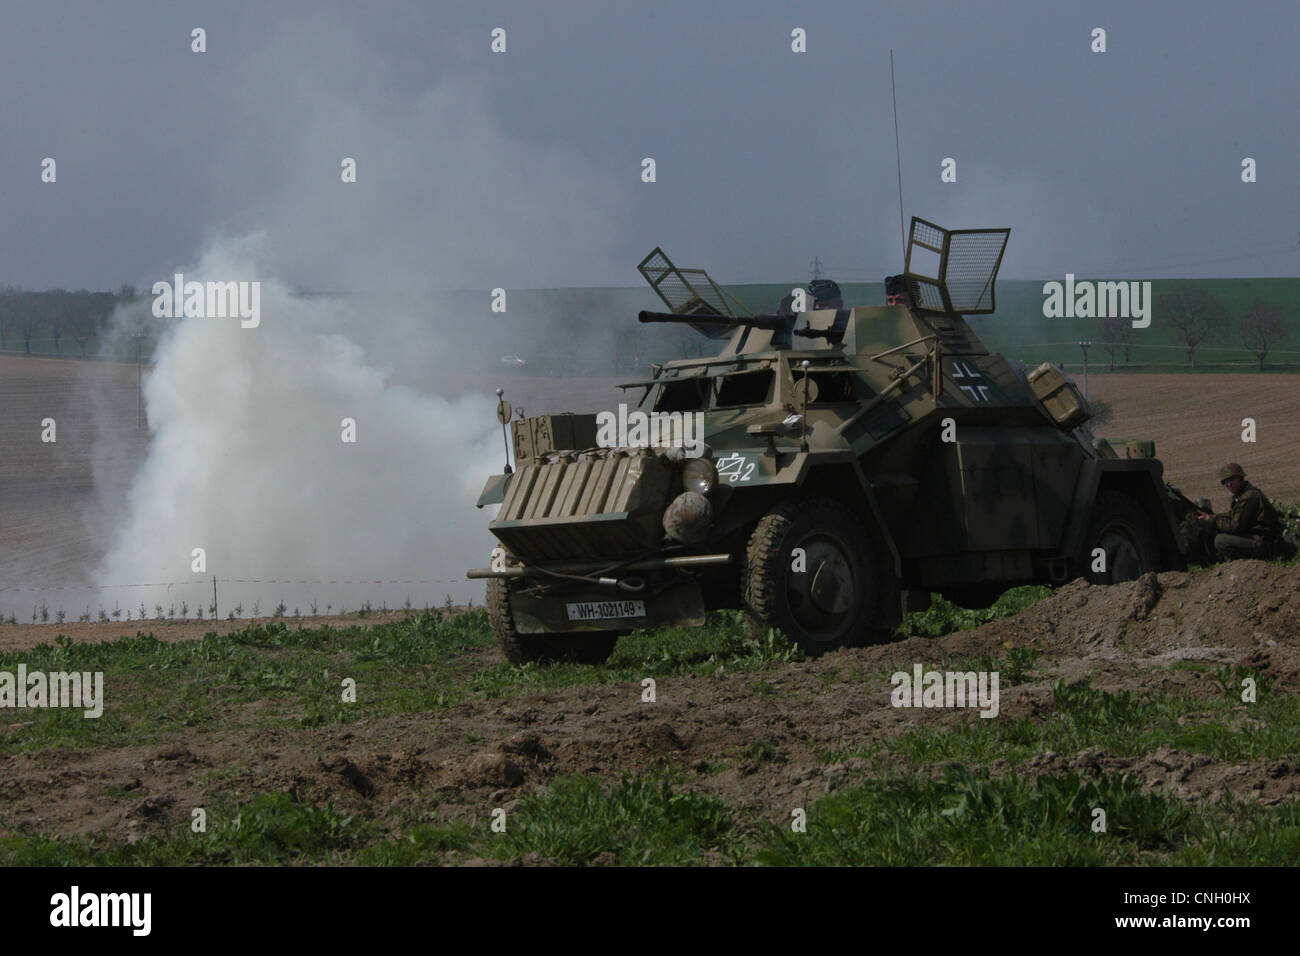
xmin=754 ymin=769 xmax=1300 ymax=866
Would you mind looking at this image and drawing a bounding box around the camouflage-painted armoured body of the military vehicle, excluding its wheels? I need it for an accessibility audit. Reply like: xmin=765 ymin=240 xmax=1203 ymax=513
xmin=471 ymin=220 xmax=1184 ymax=658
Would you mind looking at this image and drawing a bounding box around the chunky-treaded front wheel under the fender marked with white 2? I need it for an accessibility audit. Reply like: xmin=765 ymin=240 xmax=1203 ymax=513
xmin=741 ymin=498 xmax=878 ymax=657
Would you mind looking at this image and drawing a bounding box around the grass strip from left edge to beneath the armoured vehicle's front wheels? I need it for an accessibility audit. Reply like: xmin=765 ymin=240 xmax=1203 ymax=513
xmin=0 ymin=610 xmax=800 ymax=753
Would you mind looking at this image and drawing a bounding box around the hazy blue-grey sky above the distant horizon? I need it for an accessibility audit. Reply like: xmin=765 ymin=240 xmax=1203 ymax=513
xmin=0 ymin=0 xmax=1300 ymax=290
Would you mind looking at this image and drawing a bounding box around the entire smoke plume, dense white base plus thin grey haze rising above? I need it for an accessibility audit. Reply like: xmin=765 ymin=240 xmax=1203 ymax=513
xmin=87 ymin=26 xmax=629 ymax=617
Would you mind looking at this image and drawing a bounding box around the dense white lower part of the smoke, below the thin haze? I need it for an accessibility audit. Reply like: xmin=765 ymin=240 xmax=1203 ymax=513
xmin=99 ymin=239 xmax=501 ymax=615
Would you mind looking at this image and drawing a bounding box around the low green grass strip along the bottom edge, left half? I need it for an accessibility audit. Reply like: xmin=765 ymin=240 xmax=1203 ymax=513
xmin=0 ymin=775 xmax=753 ymax=866
